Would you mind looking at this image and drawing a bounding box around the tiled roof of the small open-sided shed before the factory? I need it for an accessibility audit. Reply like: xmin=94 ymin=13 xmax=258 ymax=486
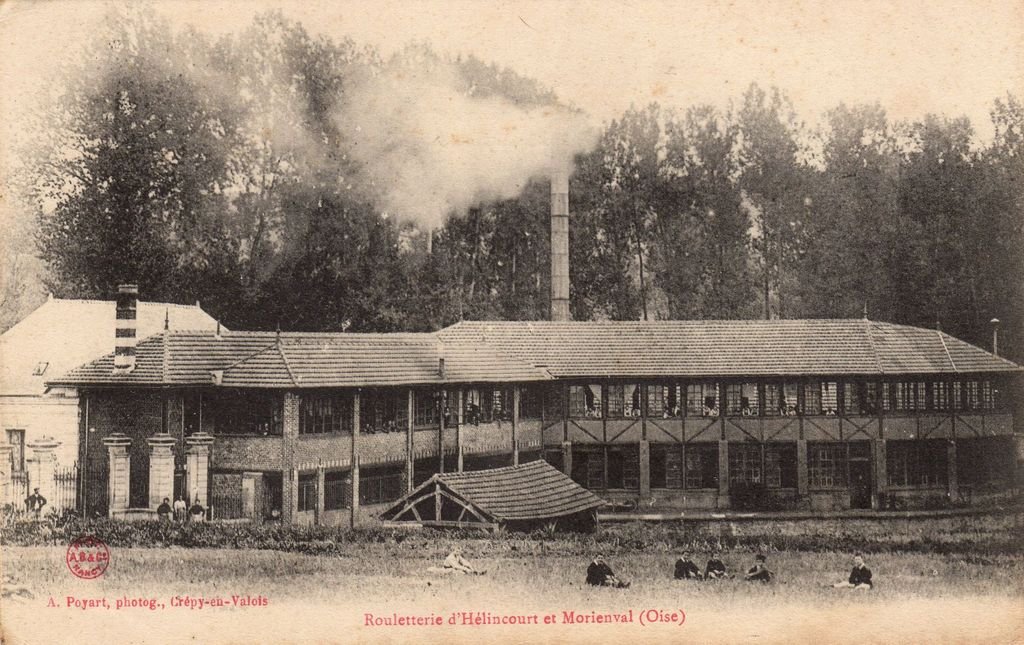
xmin=381 ymin=461 xmax=604 ymax=522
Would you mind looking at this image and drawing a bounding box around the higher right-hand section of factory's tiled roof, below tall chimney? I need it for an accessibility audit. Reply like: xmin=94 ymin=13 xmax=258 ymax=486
xmin=438 ymin=319 xmax=1021 ymax=378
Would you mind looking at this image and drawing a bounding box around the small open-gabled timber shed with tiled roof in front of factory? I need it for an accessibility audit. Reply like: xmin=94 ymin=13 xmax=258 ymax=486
xmin=380 ymin=461 xmax=604 ymax=529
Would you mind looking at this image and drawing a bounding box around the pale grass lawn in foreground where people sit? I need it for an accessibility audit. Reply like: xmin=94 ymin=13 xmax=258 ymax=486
xmin=0 ymin=540 xmax=1024 ymax=643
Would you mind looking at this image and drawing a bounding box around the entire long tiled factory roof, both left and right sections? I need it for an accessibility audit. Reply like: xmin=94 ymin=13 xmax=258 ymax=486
xmin=49 ymin=319 xmax=1021 ymax=388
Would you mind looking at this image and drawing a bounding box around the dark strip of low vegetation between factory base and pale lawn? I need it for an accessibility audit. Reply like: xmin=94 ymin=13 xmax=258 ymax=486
xmin=0 ymin=511 xmax=1024 ymax=558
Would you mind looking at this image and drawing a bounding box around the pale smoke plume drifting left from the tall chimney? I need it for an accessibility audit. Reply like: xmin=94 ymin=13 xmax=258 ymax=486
xmin=337 ymin=58 xmax=597 ymax=228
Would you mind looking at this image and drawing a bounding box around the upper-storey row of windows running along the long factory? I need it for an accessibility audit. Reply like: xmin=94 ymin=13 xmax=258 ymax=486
xmin=185 ymin=379 xmax=1005 ymax=435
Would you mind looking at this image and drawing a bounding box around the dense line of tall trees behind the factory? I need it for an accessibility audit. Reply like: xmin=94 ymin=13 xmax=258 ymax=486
xmin=20 ymin=12 xmax=1024 ymax=359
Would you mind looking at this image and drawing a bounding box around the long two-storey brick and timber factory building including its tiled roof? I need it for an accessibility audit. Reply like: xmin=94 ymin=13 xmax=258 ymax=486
xmin=51 ymin=320 xmax=1021 ymax=525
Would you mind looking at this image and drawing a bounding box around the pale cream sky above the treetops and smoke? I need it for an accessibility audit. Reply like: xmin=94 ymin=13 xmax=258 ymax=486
xmin=0 ymin=0 xmax=1024 ymax=220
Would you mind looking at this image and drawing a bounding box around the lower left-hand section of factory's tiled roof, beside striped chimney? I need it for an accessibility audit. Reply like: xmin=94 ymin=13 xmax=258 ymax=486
xmin=49 ymin=332 xmax=551 ymax=388
